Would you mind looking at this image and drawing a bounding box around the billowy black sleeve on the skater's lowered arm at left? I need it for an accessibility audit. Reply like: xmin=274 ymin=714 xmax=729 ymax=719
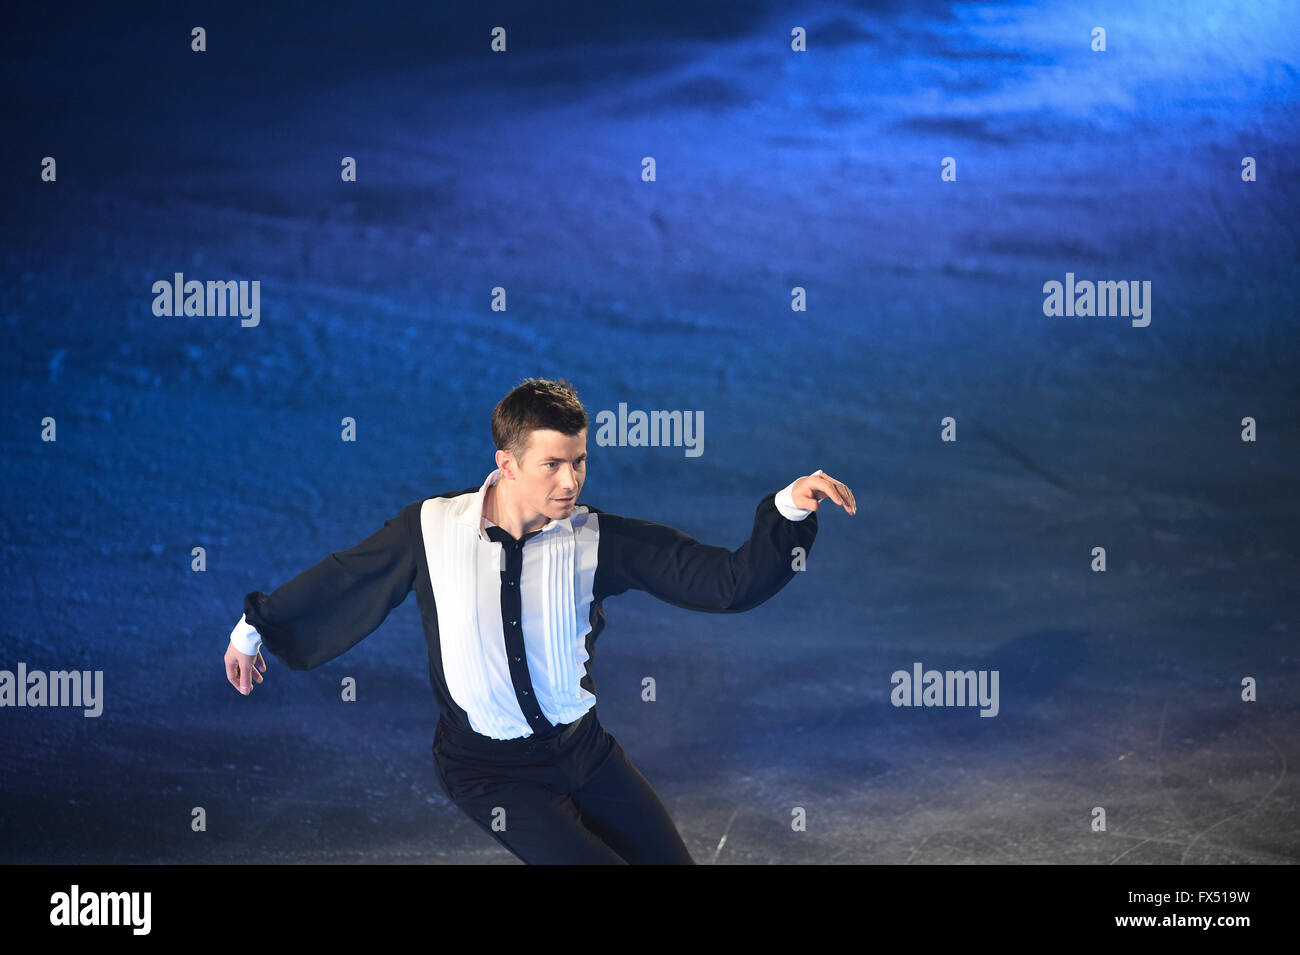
xmin=244 ymin=504 xmax=419 ymax=670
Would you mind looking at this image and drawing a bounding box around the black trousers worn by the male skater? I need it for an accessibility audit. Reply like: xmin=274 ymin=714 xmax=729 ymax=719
xmin=433 ymin=707 xmax=694 ymax=865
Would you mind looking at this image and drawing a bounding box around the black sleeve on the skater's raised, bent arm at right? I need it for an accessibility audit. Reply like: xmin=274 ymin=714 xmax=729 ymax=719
xmin=592 ymin=492 xmax=816 ymax=613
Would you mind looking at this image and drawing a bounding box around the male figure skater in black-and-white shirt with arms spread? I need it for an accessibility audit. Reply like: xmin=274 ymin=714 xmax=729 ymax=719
xmin=225 ymin=378 xmax=857 ymax=864
